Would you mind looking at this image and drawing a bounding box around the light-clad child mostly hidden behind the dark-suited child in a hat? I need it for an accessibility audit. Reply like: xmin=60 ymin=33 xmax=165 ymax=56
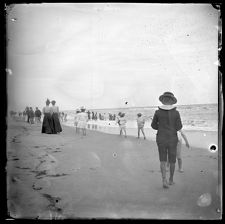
xmin=167 ymin=130 xmax=190 ymax=173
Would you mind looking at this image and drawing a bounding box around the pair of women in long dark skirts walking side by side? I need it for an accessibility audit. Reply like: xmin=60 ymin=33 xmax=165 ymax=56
xmin=41 ymin=99 xmax=62 ymax=134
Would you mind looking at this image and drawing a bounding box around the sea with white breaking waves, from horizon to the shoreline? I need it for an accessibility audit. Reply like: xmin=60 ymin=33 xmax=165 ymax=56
xmin=63 ymin=104 xmax=218 ymax=133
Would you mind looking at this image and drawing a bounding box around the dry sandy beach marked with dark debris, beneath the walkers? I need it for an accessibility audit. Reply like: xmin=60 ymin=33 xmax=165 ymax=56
xmin=7 ymin=121 xmax=221 ymax=219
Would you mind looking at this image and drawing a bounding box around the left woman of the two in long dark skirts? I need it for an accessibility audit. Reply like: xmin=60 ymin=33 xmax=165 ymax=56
xmin=41 ymin=99 xmax=53 ymax=134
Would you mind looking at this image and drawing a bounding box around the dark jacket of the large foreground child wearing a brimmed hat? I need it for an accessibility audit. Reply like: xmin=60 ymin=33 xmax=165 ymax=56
xmin=151 ymin=107 xmax=182 ymax=142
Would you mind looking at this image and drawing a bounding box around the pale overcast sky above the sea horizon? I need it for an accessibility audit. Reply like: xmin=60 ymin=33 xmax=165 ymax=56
xmin=6 ymin=3 xmax=219 ymax=111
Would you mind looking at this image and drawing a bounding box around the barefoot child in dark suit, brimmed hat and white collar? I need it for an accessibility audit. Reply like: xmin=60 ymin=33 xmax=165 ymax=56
xmin=151 ymin=92 xmax=182 ymax=188
